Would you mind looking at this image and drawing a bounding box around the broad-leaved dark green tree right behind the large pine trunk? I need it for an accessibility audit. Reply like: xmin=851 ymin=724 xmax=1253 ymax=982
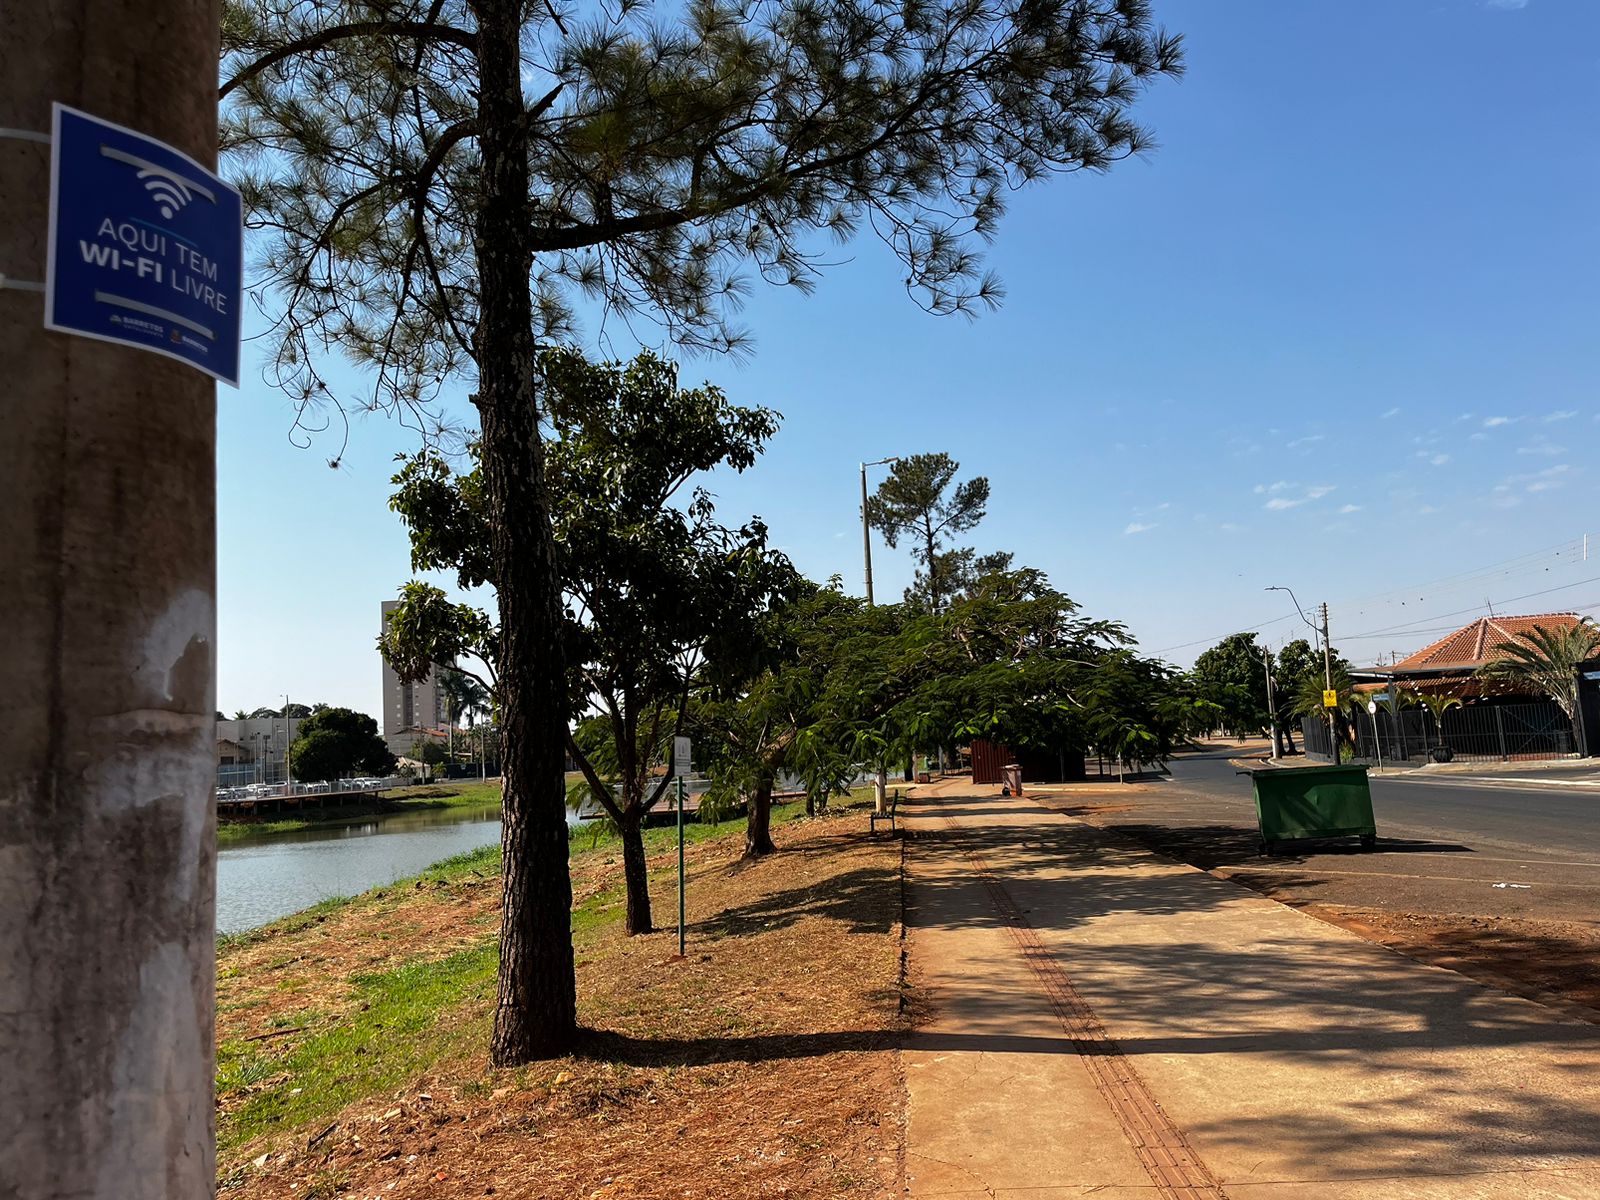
xmin=379 ymin=350 xmax=795 ymax=933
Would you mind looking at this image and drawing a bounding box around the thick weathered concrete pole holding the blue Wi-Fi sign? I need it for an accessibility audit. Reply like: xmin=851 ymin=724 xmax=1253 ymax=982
xmin=0 ymin=0 xmax=219 ymax=1200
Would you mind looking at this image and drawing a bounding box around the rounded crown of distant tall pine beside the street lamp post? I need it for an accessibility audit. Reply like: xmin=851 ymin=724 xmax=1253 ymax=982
xmin=867 ymin=453 xmax=1010 ymax=613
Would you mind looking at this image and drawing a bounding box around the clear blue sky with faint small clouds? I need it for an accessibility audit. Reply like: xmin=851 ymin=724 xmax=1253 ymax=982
xmin=218 ymin=0 xmax=1600 ymax=714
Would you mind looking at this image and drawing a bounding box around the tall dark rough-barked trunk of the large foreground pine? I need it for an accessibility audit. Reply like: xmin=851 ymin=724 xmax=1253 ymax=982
xmin=474 ymin=0 xmax=578 ymax=1066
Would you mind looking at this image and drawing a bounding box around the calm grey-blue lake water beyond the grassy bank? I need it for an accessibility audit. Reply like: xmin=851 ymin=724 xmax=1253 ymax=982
xmin=216 ymin=805 xmax=499 ymax=933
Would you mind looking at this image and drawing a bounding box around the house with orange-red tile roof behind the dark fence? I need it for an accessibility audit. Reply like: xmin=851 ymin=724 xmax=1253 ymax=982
xmin=1350 ymin=613 xmax=1600 ymax=757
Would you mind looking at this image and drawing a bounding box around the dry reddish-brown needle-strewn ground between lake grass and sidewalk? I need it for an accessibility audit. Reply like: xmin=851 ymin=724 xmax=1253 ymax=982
xmin=218 ymin=814 xmax=904 ymax=1200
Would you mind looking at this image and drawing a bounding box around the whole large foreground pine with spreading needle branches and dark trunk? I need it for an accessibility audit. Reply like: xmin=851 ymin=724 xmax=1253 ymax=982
xmin=221 ymin=0 xmax=1181 ymax=1064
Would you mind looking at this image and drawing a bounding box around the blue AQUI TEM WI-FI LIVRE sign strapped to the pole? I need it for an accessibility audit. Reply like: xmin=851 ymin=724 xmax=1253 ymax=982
xmin=45 ymin=104 xmax=245 ymax=387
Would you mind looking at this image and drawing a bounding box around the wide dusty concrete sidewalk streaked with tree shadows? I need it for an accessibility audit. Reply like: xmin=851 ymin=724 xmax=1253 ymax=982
xmin=902 ymin=781 xmax=1600 ymax=1200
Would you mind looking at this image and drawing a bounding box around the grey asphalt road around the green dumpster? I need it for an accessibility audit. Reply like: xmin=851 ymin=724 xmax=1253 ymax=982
xmin=1046 ymin=750 xmax=1600 ymax=925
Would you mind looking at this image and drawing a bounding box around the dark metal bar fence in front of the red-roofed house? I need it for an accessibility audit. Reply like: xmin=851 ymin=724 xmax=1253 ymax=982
xmin=1301 ymin=701 xmax=1578 ymax=763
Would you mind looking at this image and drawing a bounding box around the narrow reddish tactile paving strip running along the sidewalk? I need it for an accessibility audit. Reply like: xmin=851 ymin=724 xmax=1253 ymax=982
xmin=941 ymin=814 xmax=1227 ymax=1200
